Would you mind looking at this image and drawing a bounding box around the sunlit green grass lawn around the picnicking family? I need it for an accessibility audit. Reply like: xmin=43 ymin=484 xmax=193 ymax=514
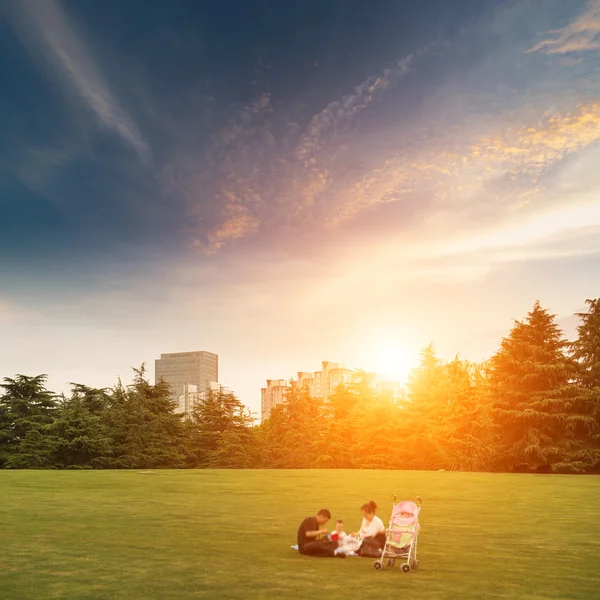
xmin=0 ymin=471 xmax=600 ymax=600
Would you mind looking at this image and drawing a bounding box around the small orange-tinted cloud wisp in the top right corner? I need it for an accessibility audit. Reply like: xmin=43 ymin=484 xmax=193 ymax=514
xmin=528 ymin=0 xmax=600 ymax=54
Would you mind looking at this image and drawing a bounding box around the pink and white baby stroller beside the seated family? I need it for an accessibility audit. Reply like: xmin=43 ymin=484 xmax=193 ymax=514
xmin=373 ymin=496 xmax=423 ymax=573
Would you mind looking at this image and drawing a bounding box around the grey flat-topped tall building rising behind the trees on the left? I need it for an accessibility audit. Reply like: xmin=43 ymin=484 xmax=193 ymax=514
xmin=155 ymin=351 xmax=219 ymax=401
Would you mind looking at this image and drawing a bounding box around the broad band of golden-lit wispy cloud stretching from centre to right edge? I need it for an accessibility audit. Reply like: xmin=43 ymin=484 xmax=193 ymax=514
xmin=165 ymin=0 xmax=600 ymax=262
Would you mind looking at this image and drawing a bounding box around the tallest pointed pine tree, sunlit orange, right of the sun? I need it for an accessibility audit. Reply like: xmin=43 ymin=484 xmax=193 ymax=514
xmin=489 ymin=302 xmax=591 ymax=472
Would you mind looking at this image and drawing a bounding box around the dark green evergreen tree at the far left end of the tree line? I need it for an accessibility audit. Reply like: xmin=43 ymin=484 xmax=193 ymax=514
xmin=0 ymin=375 xmax=57 ymax=469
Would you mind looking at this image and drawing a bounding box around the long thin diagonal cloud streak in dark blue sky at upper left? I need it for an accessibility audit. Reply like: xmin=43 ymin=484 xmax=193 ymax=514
xmin=9 ymin=0 xmax=150 ymax=162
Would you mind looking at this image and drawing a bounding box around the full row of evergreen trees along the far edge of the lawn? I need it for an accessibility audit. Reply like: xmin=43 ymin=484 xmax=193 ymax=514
xmin=0 ymin=299 xmax=600 ymax=473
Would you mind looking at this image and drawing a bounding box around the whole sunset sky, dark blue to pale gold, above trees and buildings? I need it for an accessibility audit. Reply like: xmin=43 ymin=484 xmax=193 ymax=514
xmin=0 ymin=0 xmax=600 ymax=411
